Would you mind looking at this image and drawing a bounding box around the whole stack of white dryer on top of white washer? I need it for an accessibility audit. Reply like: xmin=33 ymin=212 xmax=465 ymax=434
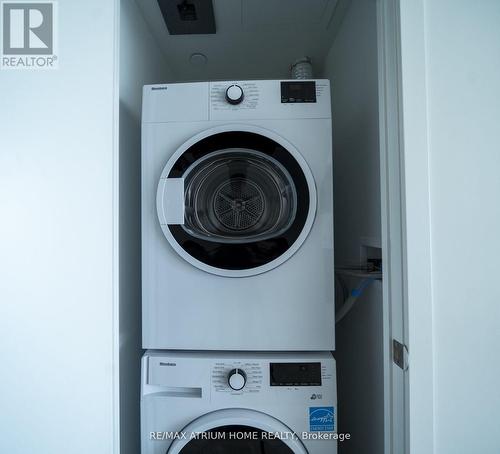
xmin=141 ymin=80 xmax=337 ymax=454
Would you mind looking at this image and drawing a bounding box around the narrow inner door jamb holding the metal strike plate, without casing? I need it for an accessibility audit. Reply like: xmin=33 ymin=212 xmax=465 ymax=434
xmin=377 ymin=0 xmax=408 ymax=454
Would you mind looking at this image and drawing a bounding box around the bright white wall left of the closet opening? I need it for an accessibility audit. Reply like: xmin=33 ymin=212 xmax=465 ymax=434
xmin=0 ymin=0 xmax=118 ymax=454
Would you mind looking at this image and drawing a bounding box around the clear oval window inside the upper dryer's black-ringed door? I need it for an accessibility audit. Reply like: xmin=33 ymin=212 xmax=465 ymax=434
xmin=183 ymin=148 xmax=297 ymax=244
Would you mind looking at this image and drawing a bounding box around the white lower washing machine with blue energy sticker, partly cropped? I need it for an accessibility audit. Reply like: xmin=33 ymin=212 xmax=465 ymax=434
xmin=141 ymin=351 xmax=337 ymax=454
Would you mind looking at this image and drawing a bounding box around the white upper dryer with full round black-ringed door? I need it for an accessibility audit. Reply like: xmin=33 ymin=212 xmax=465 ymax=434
xmin=142 ymin=80 xmax=335 ymax=351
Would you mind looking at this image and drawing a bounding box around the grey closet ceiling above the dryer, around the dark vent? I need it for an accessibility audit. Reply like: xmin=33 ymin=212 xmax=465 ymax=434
xmin=136 ymin=0 xmax=342 ymax=81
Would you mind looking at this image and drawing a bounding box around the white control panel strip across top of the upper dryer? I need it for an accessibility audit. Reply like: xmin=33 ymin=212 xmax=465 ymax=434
xmin=142 ymin=79 xmax=331 ymax=123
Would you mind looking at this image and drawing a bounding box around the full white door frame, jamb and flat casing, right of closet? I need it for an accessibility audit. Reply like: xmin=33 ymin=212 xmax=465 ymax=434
xmin=377 ymin=0 xmax=434 ymax=454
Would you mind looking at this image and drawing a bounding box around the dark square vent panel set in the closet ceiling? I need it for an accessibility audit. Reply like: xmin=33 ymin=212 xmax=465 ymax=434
xmin=158 ymin=0 xmax=215 ymax=35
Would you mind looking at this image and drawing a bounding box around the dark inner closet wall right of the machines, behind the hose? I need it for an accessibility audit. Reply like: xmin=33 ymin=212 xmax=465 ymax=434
xmin=323 ymin=0 xmax=384 ymax=454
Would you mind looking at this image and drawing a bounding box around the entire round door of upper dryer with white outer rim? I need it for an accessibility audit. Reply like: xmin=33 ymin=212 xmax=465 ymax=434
xmin=157 ymin=125 xmax=316 ymax=277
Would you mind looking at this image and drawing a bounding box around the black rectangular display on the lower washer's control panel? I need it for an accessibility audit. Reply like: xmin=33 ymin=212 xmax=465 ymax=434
xmin=270 ymin=363 xmax=321 ymax=386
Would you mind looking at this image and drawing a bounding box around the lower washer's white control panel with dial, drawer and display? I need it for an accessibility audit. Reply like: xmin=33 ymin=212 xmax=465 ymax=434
xmin=143 ymin=351 xmax=336 ymax=408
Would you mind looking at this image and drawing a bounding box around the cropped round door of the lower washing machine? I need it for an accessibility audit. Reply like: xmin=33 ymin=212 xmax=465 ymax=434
xmin=167 ymin=408 xmax=307 ymax=454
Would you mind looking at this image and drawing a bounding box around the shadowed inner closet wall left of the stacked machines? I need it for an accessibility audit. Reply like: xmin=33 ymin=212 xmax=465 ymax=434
xmin=119 ymin=0 xmax=173 ymax=454
